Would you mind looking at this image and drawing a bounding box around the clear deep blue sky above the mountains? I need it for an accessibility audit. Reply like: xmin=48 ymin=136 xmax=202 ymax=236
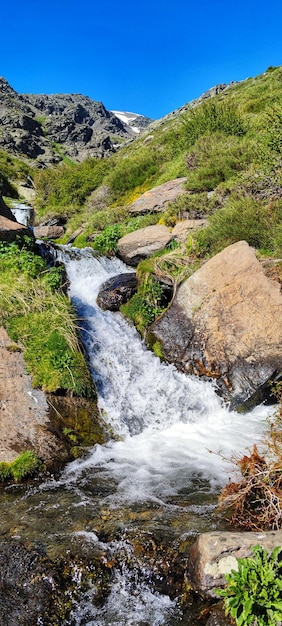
xmin=0 ymin=0 xmax=282 ymax=118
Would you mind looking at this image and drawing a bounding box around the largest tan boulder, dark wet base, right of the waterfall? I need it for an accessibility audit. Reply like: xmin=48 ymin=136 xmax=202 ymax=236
xmin=152 ymin=241 xmax=282 ymax=406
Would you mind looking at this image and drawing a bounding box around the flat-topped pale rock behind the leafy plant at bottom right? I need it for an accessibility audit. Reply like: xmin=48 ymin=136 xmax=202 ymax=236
xmin=188 ymin=530 xmax=282 ymax=598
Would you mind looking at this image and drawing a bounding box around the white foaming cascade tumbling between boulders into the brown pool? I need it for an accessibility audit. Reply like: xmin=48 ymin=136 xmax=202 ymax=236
xmin=56 ymin=244 xmax=269 ymax=507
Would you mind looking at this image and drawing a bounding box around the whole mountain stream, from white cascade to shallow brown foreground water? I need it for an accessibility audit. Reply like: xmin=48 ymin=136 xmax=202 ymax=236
xmin=1 ymin=247 xmax=272 ymax=626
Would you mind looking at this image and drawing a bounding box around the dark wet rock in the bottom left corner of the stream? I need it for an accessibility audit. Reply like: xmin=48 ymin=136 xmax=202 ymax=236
xmin=0 ymin=540 xmax=110 ymax=626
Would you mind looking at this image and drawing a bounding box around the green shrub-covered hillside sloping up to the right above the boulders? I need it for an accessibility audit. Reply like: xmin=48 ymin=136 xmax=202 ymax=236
xmin=29 ymin=67 xmax=282 ymax=255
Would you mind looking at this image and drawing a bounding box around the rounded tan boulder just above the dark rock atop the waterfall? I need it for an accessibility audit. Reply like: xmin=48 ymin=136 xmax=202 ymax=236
xmin=118 ymin=225 xmax=171 ymax=266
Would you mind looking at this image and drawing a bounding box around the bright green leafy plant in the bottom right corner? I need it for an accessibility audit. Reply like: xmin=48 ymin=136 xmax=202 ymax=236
xmin=217 ymin=545 xmax=282 ymax=626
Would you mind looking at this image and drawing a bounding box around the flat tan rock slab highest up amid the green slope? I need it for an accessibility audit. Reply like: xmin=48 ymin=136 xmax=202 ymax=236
xmin=128 ymin=177 xmax=187 ymax=215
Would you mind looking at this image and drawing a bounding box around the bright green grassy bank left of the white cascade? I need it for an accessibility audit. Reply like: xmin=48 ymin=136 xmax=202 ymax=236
xmin=0 ymin=239 xmax=94 ymax=398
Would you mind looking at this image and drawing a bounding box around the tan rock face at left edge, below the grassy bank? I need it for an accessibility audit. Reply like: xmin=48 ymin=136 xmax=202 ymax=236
xmin=0 ymin=327 xmax=67 ymax=464
